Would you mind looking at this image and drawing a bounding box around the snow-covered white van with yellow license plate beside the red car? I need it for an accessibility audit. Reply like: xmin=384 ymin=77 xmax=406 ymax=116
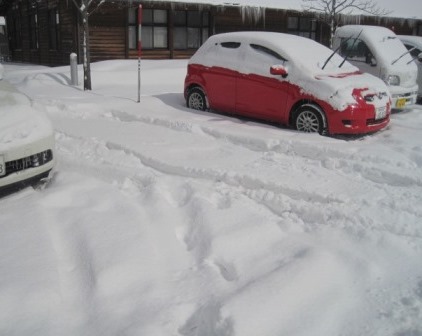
xmin=333 ymin=25 xmax=418 ymax=109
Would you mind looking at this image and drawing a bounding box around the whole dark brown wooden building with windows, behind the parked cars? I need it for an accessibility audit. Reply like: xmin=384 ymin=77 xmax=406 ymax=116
xmin=0 ymin=0 xmax=422 ymax=65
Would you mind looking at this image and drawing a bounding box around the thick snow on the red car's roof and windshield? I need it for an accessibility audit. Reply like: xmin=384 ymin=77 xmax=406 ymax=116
xmin=199 ymin=31 xmax=358 ymax=76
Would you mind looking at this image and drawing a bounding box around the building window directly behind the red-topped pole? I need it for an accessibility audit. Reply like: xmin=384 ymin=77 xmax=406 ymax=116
xmin=129 ymin=8 xmax=168 ymax=49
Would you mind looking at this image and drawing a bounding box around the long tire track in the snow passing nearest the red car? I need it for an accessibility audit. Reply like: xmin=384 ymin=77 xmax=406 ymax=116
xmin=111 ymin=110 xmax=422 ymax=187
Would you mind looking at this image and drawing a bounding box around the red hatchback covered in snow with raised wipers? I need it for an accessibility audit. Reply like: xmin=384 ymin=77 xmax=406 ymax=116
xmin=184 ymin=32 xmax=391 ymax=134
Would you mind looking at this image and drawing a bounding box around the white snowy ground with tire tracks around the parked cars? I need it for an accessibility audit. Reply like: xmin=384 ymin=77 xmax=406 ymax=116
xmin=0 ymin=61 xmax=422 ymax=336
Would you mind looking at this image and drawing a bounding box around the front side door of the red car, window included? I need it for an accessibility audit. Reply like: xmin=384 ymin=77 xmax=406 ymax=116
xmin=236 ymin=44 xmax=290 ymax=121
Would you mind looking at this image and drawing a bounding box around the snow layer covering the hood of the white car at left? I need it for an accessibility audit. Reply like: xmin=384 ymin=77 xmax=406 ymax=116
xmin=0 ymin=81 xmax=53 ymax=152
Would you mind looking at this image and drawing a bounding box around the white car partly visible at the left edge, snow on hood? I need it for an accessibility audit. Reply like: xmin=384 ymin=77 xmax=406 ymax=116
xmin=0 ymin=79 xmax=55 ymax=197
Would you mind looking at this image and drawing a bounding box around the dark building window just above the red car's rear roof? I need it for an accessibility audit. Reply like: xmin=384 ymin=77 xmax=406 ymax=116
xmin=174 ymin=10 xmax=209 ymax=49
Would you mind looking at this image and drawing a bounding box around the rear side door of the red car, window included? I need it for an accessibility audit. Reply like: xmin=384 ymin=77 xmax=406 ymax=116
xmin=203 ymin=42 xmax=241 ymax=113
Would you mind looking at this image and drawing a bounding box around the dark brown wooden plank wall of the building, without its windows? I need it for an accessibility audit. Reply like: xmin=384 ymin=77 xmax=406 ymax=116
xmin=4 ymin=0 xmax=422 ymax=65
